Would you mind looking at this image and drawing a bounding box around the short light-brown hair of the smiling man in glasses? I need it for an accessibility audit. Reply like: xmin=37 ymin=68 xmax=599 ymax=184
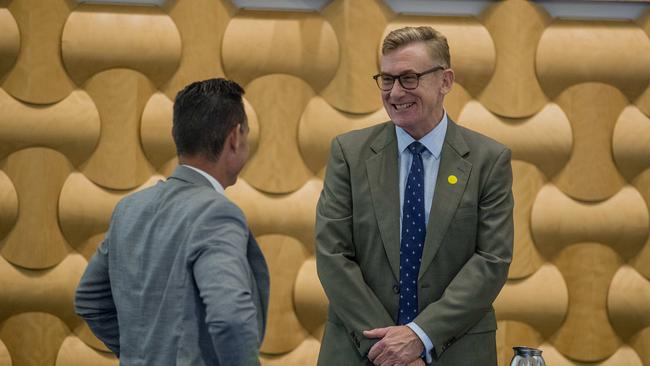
xmin=381 ymin=26 xmax=451 ymax=68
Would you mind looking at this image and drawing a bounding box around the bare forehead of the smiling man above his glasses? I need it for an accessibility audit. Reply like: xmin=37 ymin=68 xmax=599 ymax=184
xmin=381 ymin=42 xmax=435 ymax=75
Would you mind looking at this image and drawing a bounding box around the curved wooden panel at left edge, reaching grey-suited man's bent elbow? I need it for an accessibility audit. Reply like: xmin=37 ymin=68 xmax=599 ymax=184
xmin=0 ymin=254 xmax=86 ymax=329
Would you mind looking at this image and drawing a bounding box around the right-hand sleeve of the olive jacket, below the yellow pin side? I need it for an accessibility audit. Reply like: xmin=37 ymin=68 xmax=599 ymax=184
xmin=414 ymin=149 xmax=513 ymax=358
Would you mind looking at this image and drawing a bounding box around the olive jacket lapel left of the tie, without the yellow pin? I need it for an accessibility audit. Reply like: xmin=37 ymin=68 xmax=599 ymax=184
xmin=366 ymin=123 xmax=400 ymax=278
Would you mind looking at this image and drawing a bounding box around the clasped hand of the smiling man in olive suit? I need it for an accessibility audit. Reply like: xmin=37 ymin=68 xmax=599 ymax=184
xmin=363 ymin=325 xmax=424 ymax=366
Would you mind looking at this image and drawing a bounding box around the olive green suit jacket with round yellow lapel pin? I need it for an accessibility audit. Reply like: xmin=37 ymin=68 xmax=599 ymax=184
xmin=316 ymin=120 xmax=513 ymax=365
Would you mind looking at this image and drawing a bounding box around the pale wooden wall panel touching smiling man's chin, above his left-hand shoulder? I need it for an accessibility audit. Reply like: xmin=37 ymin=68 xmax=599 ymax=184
xmin=298 ymin=96 xmax=390 ymax=174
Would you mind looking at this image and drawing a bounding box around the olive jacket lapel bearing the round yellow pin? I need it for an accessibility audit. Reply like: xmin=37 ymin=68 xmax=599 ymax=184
xmin=418 ymin=120 xmax=472 ymax=279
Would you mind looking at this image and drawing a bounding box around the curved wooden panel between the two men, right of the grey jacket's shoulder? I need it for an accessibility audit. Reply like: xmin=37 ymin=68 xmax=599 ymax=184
xmin=226 ymin=178 xmax=323 ymax=253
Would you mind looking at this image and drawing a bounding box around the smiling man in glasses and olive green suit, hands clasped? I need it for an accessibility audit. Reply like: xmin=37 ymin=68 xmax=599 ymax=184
xmin=316 ymin=27 xmax=513 ymax=366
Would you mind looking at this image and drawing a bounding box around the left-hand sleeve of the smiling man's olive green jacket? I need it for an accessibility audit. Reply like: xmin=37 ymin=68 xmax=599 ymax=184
xmin=316 ymin=139 xmax=395 ymax=357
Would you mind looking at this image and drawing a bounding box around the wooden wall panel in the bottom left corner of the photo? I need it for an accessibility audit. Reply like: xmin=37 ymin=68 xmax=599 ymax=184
xmin=0 ymin=313 xmax=70 ymax=366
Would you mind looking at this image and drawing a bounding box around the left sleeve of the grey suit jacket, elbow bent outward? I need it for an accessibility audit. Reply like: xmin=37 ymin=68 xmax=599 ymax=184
xmin=75 ymin=234 xmax=120 ymax=357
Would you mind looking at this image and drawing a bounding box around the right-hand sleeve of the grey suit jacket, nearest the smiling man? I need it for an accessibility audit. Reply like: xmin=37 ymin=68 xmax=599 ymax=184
xmin=189 ymin=203 xmax=261 ymax=366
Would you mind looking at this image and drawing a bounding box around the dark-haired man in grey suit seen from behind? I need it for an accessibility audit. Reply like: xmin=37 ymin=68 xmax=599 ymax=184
xmin=75 ymin=79 xmax=269 ymax=366
